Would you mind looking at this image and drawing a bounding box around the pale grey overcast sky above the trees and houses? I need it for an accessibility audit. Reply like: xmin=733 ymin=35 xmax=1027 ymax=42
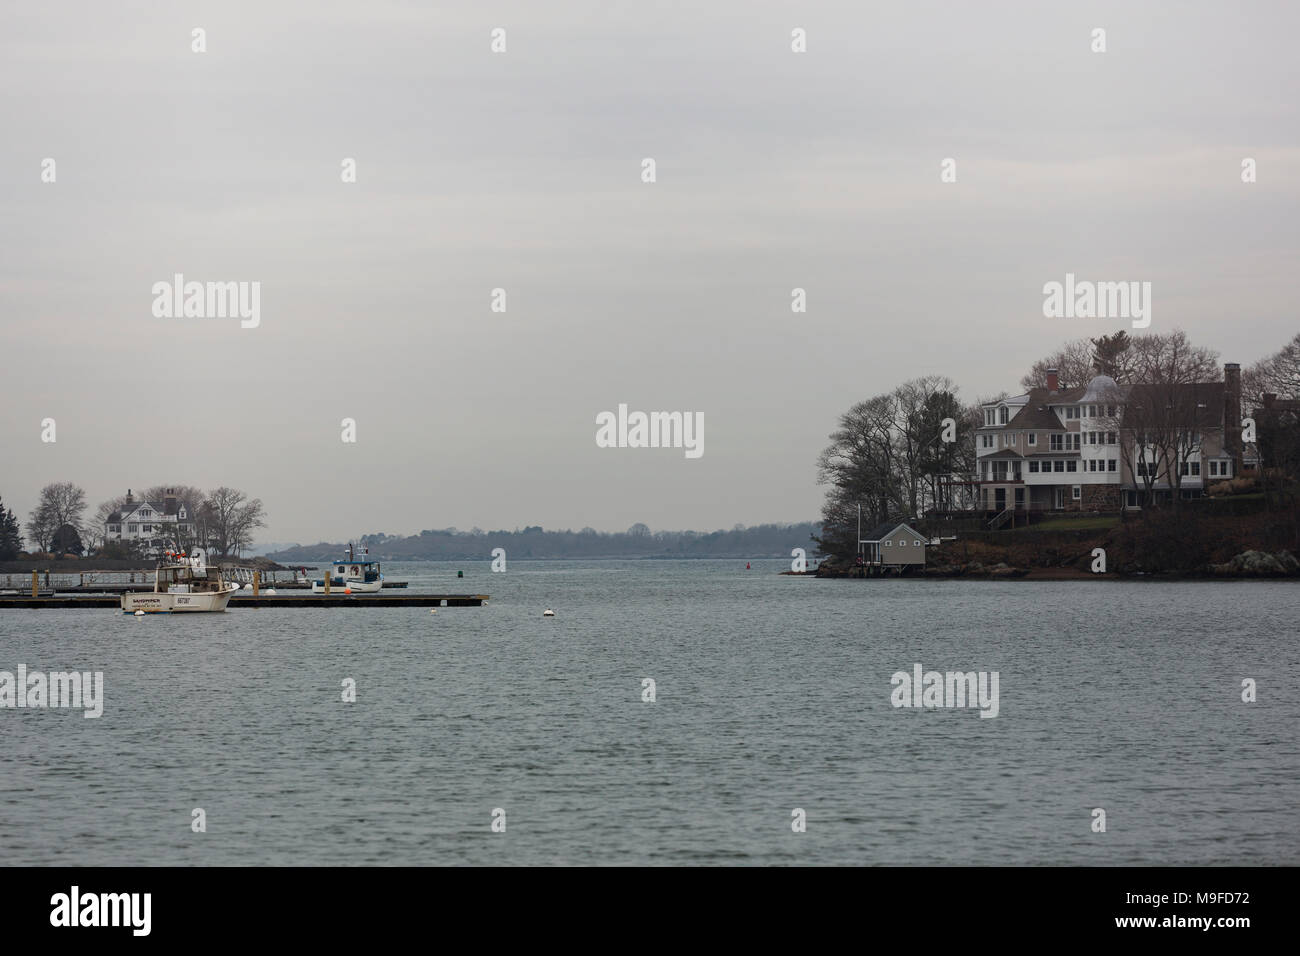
xmin=0 ymin=0 xmax=1300 ymax=541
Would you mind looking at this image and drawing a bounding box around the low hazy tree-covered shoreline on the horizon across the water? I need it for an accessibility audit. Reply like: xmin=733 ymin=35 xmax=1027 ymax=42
xmin=268 ymin=522 xmax=819 ymax=564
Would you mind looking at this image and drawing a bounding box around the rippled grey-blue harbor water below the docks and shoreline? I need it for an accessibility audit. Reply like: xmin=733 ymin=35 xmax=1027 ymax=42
xmin=0 ymin=559 xmax=1300 ymax=865
